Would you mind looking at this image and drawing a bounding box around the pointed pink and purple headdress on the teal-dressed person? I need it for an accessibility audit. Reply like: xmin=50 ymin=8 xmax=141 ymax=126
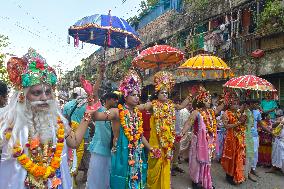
xmin=119 ymin=70 xmax=141 ymax=97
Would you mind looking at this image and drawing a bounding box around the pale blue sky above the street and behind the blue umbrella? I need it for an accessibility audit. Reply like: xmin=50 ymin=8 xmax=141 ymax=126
xmin=0 ymin=0 xmax=141 ymax=71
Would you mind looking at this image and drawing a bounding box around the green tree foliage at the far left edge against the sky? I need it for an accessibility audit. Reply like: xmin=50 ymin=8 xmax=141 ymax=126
xmin=0 ymin=34 xmax=9 ymax=83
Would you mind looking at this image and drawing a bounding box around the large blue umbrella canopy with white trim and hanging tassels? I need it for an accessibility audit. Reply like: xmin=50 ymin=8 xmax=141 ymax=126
xmin=68 ymin=14 xmax=141 ymax=49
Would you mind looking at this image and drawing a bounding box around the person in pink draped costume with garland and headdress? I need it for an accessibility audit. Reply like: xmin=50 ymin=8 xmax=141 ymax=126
xmin=181 ymin=87 xmax=223 ymax=189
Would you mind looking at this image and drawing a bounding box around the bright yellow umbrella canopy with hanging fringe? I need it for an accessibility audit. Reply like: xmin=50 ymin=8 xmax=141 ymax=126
xmin=178 ymin=54 xmax=233 ymax=78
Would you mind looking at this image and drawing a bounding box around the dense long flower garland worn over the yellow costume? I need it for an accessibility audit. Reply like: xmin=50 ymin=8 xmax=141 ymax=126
xmin=152 ymin=100 xmax=176 ymax=159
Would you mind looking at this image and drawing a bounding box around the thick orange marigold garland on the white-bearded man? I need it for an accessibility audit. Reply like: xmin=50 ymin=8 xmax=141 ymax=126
xmin=13 ymin=117 xmax=64 ymax=186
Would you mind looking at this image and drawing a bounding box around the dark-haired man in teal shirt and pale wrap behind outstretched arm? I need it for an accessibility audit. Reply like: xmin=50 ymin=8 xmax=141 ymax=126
xmin=87 ymin=93 xmax=118 ymax=189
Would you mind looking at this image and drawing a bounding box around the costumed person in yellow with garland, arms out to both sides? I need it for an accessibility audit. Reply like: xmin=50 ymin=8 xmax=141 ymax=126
xmin=139 ymin=71 xmax=189 ymax=189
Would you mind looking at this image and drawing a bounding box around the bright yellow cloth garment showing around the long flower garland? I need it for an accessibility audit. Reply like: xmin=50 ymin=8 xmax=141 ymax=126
xmin=147 ymin=116 xmax=171 ymax=189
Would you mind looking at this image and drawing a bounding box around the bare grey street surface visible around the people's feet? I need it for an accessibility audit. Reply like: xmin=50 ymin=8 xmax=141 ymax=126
xmin=77 ymin=160 xmax=284 ymax=189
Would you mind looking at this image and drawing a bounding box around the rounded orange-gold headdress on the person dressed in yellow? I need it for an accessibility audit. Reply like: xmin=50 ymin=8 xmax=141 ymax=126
xmin=154 ymin=71 xmax=175 ymax=92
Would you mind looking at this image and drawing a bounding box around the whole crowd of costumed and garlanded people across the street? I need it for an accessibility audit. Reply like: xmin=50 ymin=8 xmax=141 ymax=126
xmin=0 ymin=49 xmax=284 ymax=189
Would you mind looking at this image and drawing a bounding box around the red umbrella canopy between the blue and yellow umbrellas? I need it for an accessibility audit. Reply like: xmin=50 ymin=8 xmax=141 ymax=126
xmin=132 ymin=45 xmax=184 ymax=69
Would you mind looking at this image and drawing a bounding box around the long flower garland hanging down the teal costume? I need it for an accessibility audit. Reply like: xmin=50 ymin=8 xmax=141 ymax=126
xmin=118 ymin=104 xmax=144 ymax=183
